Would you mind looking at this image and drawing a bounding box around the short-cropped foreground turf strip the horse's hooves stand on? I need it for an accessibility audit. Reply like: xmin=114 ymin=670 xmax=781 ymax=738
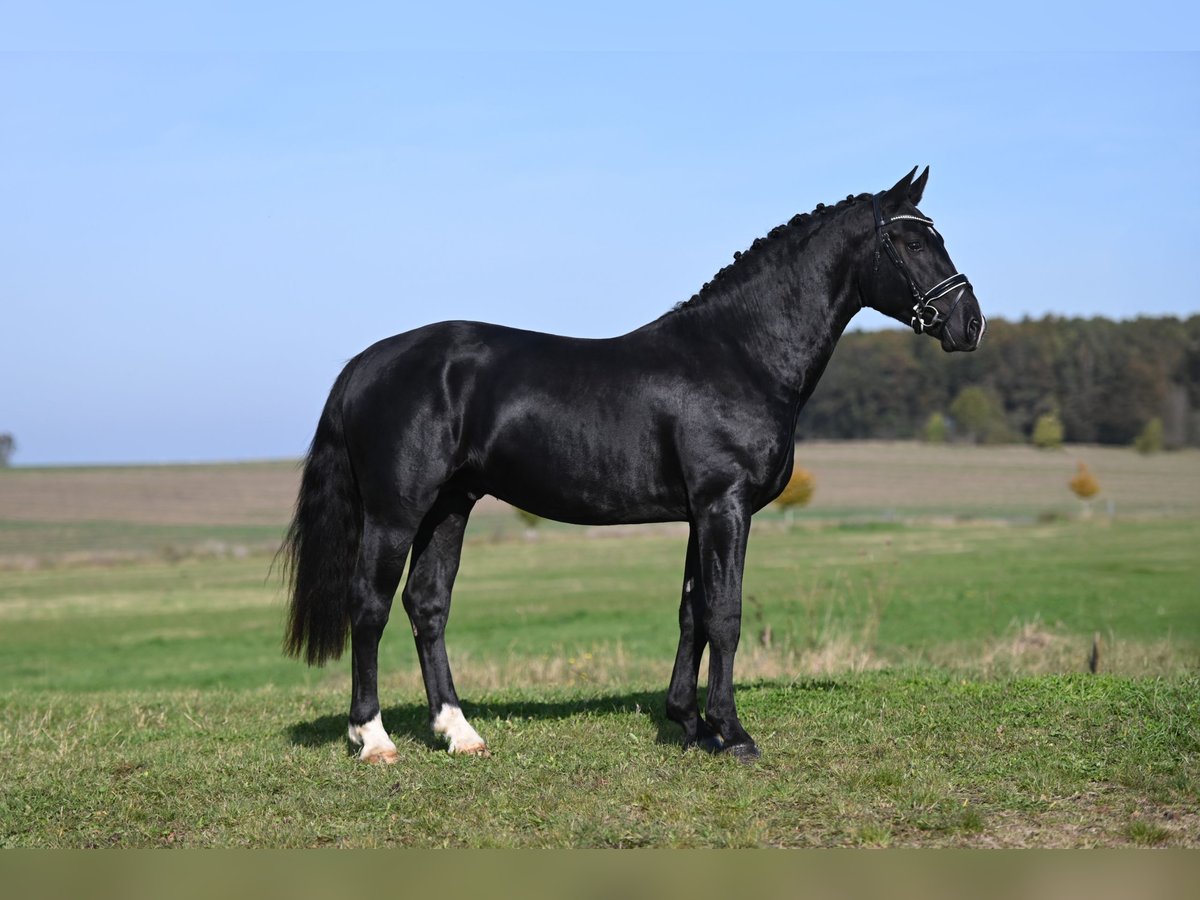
xmin=0 ymin=672 xmax=1200 ymax=847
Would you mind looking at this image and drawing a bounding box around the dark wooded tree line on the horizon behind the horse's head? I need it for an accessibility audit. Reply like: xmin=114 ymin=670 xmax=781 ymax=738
xmin=798 ymin=316 xmax=1200 ymax=448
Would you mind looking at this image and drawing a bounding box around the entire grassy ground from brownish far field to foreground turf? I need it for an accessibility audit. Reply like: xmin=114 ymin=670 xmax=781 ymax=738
xmin=0 ymin=444 xmax=1200 ymax=847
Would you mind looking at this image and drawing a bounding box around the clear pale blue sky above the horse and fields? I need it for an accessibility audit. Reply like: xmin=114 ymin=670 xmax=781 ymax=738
xmin=0 ymin=12 xmax=1200 ymax=464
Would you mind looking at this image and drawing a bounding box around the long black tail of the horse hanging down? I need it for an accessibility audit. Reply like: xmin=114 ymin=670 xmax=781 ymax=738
xmin=280 ymin=360 xmax=362 ymax=666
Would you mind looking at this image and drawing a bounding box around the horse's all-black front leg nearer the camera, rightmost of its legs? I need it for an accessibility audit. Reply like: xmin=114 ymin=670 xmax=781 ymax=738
xmin=692 ymin=496 xmax=758 ymax=761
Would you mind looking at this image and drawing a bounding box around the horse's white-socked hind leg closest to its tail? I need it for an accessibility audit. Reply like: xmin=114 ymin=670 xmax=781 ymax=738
xmin=349 ymin=516 xmax=415 ymax=763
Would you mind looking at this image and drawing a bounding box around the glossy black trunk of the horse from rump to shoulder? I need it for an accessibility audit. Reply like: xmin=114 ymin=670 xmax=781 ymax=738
xmin=346 ymin=322 xmax=685 ymax=523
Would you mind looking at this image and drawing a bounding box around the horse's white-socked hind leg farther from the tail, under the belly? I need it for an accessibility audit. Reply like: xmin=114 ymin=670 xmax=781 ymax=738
xmin=403 ymin=488 xmax=487 ymax=756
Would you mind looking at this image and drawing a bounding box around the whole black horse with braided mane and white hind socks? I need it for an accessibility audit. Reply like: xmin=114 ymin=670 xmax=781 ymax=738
xmin=284 ymin=168 xmax=985 ymax=762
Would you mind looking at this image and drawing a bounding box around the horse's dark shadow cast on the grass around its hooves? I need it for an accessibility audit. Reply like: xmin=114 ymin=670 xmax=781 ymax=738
xmin=288 ymin=678 xmax=845 ymax=752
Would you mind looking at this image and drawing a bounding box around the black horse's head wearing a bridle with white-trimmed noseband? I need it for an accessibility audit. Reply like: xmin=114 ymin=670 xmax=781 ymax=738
xmin=863 ymin=166 xmax=988 ymax=353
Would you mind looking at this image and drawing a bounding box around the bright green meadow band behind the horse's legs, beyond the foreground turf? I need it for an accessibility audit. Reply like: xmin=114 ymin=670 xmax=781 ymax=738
xmin=0 ymin=521 xmax=1200 ymax=691
